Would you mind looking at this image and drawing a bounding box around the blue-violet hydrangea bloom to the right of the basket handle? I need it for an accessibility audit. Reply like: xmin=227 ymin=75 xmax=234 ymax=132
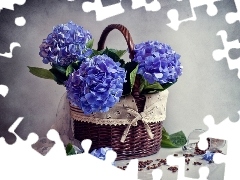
xmin=134 ymin=41 xmax=182 ymax=84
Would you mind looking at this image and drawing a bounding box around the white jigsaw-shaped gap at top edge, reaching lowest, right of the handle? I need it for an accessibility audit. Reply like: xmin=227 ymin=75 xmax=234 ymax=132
xmin=167 ymin=0 xmax=222 ymax=31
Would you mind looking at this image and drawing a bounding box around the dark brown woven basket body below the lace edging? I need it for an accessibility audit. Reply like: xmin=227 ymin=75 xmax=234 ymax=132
xmin=74 ymin=121 xmax=162 ymax=160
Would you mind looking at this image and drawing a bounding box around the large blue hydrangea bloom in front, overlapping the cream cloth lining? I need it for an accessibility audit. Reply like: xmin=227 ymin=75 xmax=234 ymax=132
xmin=65 ymin=55 xmax=126 ymax=114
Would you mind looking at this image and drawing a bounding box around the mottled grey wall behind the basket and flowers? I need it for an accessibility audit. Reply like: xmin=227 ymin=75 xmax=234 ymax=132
xmin=0 ymin=0 xmax=240 ymax=144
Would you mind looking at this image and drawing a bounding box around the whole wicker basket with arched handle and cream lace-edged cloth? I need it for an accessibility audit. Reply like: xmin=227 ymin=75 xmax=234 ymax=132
xmin=70 ymin=24 xmax=168 ymax=160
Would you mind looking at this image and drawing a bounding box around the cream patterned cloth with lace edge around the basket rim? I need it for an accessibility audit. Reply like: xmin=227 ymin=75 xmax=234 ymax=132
xmin=70 ymin=90 xmax=168 ymax=126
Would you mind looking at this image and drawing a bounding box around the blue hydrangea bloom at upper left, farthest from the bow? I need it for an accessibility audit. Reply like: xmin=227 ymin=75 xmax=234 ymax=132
xmin=39 ymin=21 xmax=92 ymax=66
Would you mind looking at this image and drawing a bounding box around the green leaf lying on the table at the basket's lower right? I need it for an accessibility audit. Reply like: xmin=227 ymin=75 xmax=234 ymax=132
xmin=161 ymin=128 xmax=187 ymax=148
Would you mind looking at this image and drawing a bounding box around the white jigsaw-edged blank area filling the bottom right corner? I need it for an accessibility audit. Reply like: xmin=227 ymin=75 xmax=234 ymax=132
xmin=199 ymin=111 xmax=240 ymax=180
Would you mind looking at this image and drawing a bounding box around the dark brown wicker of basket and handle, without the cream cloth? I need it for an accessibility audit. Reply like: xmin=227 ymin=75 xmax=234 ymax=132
xmin=70 ymin=24 xmax=167 ymax=160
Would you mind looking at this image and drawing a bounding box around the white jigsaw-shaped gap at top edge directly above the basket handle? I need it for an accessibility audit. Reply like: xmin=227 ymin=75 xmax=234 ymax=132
xmin=82 ymin=0 xmax=124 ymax=21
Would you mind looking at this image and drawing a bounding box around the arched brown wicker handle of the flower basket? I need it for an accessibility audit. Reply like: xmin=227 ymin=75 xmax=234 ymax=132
xmin=97 ymin=24 xmax=141 ymax=109
